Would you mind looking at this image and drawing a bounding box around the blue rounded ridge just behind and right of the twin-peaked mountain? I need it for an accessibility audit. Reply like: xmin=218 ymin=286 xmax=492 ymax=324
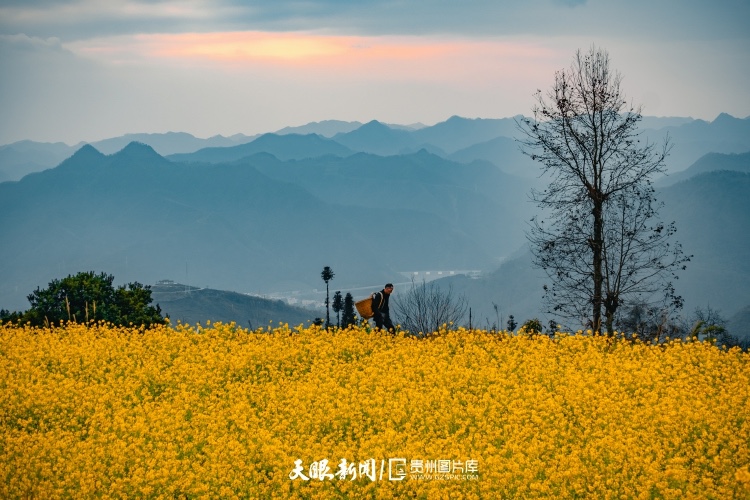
xmin=169 ymin=134 xmax=352 ymax=163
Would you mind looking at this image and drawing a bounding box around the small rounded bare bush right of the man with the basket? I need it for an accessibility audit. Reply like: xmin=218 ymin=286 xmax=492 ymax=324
xmin=393 ymin=281 xmax=467 ymax=337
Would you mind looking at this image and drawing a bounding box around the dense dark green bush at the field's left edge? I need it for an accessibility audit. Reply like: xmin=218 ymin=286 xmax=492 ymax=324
xmin=0 ymin=271 xmax=165 ymax=326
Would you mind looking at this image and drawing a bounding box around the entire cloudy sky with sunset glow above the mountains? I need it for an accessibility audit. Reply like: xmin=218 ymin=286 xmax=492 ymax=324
xmin=0 ymin=0 xmax=750 ymax=145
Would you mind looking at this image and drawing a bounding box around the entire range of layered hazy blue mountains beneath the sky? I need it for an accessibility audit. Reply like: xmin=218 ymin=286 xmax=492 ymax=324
xmin=0 ymin=115 xmax=750 ymax=338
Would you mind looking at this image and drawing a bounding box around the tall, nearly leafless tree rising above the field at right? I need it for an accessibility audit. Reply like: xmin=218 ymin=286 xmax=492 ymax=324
xmin=518 ymin=47 xmax=689 ymax=333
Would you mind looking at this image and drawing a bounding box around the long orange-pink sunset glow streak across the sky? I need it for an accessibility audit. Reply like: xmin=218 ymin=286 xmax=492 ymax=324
xmin=70 ymin=31 xmax=549 ymax=69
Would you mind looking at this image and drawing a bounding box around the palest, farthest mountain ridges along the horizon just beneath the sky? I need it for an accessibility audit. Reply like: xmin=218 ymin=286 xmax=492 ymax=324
xmin=5 ymin=113 xmax=750 ymax=182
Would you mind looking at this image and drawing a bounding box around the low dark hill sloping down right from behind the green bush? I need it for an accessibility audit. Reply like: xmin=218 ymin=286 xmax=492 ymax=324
xmin=151 ymin=281 xmax=321 ymax=330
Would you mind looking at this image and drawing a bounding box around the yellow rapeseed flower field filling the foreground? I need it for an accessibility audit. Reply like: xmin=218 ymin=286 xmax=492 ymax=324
xmin=0 ymin=324 xmax=750 ymax=499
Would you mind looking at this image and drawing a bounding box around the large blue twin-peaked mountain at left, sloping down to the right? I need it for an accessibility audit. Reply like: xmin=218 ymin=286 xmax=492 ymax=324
xmin=0 ymin=143 xmax=494 ymax=309
